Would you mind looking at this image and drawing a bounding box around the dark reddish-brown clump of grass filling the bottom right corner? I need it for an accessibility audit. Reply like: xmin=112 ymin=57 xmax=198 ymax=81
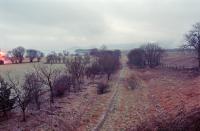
xmin=134 ymin=108 xmax=200 ymax=131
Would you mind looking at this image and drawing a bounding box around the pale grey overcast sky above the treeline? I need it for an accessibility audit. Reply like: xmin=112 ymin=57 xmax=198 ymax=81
xmin=0 ymin=0 xmax=200 ymax=50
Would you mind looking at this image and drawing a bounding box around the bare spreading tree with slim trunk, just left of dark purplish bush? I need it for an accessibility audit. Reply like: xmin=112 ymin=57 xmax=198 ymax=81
xmin=34 ymin=64 xmax=60 ymax=103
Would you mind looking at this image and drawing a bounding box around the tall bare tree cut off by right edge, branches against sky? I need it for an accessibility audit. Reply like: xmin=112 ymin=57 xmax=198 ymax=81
xmin=183 ymin=23 xmax=200 ymax=68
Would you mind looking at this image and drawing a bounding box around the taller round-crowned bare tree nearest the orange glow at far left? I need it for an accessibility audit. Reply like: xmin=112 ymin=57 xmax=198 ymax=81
xmin=12 ymin=46 xmax=25 ymax=63
